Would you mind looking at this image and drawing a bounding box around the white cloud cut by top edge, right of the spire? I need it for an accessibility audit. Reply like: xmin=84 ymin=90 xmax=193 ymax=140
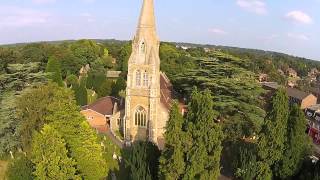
xmin=237 ymin=0 xmax=268 ymax=15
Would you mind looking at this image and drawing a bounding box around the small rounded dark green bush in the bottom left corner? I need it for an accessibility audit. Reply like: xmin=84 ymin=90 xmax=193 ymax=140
xmin=6 ymin=156 xmax=34 ymax=180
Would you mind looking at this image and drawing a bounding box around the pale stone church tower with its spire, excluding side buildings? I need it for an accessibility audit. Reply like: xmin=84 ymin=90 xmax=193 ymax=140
xmin=123 ymin=0 xmax=161 ymax=143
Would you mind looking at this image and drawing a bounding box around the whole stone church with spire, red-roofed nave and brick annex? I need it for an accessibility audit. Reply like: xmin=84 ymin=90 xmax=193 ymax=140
xmin=82 ymin=0 xmax=182 ymax=148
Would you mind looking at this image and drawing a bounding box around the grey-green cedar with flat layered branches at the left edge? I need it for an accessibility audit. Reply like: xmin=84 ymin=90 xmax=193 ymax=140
xmin=0 ymin=63 xmax=46 ymax=155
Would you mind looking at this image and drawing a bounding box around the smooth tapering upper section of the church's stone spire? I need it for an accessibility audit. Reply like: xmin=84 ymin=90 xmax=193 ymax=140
xmin=138 ymin=0 xmax=156 ymax=29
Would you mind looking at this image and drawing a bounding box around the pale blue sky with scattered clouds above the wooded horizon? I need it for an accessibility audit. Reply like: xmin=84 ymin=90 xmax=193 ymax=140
xmin=0 ymin=0 xmax=320 ymax=60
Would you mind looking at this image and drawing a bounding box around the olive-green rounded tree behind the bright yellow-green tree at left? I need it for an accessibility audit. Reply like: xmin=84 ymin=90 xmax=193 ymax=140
xmin=17 ymin=83 xmax=74 ymax=148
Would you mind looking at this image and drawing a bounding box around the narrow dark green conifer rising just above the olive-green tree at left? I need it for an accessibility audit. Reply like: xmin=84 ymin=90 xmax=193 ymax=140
xmin=46 ymin=57 xmax=63 ymax=86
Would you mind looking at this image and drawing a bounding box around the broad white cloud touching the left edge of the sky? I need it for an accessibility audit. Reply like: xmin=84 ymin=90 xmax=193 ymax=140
xmin=0 ymin=6 xmax=50 ymax=28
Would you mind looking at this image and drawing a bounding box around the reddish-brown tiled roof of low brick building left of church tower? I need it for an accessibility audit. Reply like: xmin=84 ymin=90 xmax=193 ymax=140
xmin=82 ymin=96 xmax=120 ymax=116
